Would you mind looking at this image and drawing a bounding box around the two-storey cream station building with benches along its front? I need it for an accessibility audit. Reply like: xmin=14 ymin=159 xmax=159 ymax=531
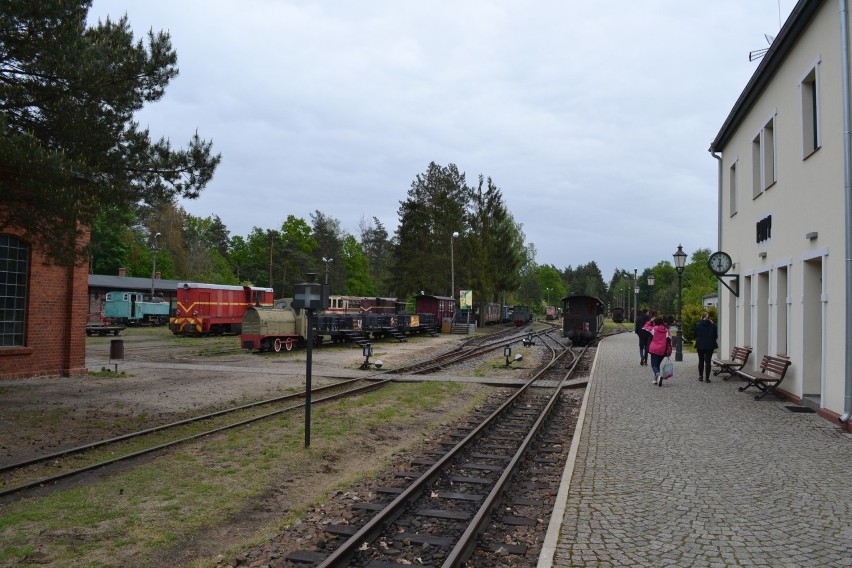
xmin=710 ymin=0 xmax=852 ymax=430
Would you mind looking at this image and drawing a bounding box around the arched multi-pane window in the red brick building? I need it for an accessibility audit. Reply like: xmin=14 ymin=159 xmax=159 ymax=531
xmin=0 ymin=235 xmax=30 ymax=347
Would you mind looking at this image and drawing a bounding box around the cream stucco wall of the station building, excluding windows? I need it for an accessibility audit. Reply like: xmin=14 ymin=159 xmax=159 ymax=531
xmin=720 ymin=2 xmax=846 ymax=414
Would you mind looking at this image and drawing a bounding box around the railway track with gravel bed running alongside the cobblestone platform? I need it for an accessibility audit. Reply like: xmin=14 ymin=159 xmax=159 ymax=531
xmin=272 ymin=340 xmax=592 ymax=568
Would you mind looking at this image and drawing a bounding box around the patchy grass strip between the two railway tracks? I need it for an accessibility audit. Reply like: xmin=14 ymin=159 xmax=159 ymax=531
xmin=0 ymin=382 xmax=484 ymax=567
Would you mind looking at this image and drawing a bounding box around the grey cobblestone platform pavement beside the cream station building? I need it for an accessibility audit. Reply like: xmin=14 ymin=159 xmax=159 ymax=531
xmin=539 ymin=333 xmax=852 ymax=567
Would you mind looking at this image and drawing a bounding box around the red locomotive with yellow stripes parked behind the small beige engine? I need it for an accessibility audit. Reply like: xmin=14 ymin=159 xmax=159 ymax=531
xmin=169 ymin=282 xmax=273 ymax=335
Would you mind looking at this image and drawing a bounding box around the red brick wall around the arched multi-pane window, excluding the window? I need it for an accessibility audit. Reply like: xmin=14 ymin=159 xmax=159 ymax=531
xmin=0 ymin=225 xmax=88 ymax=379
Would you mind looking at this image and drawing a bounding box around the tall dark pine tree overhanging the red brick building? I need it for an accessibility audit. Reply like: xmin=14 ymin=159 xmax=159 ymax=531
xmin=0 ymin=0 xmax=220 ymax=263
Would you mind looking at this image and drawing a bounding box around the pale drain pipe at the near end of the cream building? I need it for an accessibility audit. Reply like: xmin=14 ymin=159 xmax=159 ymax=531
xmin=839 ymin=0 xmax=852 ymax=425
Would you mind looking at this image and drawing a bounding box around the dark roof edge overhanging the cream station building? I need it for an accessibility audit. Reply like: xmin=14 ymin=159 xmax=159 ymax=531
xmin=710 ymin=0 xmax=825 ymax=152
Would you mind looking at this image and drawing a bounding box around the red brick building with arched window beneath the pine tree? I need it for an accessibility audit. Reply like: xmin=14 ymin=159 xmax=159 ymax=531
xmin=0 ymin=228 xmax=88 ymax=379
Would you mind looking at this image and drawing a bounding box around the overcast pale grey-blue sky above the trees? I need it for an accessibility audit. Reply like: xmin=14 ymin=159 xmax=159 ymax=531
xmin=90 ymin=0 xmax=795 ymax=282
